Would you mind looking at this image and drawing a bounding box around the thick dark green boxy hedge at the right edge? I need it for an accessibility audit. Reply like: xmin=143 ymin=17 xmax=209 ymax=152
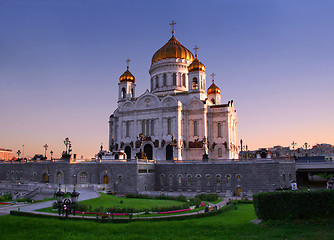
xmin=253 ymin=190 xmax=334 ymax=221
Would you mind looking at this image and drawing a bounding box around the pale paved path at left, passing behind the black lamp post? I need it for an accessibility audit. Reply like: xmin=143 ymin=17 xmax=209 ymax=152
xmin=0 ymin=188 xmax=100 ymax=215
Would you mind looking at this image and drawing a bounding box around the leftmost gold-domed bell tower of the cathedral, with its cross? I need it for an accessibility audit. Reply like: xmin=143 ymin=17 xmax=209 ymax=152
xmin=118 ymin=59 xmax=136 ymax=106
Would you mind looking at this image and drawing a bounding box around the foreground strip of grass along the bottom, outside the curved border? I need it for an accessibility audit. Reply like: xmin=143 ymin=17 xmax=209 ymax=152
xmin=0 ymin=204 xmax=334 ymax=240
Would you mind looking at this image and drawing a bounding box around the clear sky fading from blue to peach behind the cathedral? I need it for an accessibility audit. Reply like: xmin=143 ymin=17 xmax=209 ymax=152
xmin=0 ymin=0 xmax=334 ymax=158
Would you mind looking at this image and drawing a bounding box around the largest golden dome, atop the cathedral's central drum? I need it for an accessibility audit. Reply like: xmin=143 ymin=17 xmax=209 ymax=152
xmin=152 ymin=34 xmax=194 ymax=63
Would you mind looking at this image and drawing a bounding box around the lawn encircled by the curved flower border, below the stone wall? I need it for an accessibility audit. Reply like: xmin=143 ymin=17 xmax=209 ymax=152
xmin=38 ymin=193 xmax=185 ymax=212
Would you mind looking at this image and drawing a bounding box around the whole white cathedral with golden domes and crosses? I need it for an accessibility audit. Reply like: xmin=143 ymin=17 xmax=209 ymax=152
xmin=109 ymin=22 xmax=238 ymax=161
